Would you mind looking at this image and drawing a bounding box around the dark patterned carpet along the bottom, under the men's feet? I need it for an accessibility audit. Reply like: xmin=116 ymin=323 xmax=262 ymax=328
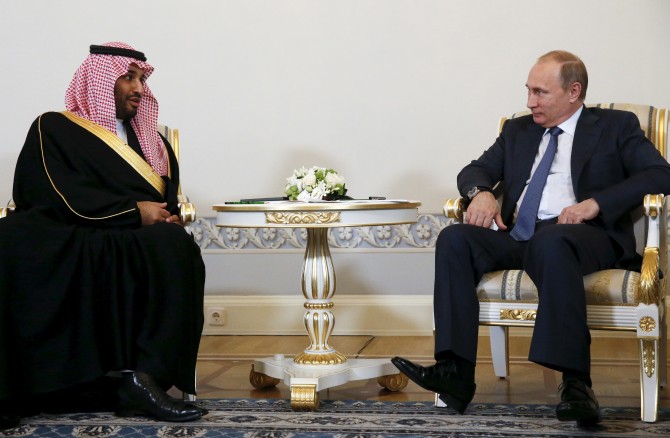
xmin=0 ymin=399 xmax=670 ymax=438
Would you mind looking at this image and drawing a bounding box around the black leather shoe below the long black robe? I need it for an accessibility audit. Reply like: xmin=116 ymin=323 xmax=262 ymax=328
xmin=116 ymin=371 xmax=203 ymax=422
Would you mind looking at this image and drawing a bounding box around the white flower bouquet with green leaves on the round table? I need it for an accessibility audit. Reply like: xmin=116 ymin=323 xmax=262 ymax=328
xmin=284 ymin=166 xmax=347 ymax=202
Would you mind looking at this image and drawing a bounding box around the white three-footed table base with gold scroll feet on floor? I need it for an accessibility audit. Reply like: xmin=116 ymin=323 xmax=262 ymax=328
xmin=250 ymin=355 xmax=408 ymax=410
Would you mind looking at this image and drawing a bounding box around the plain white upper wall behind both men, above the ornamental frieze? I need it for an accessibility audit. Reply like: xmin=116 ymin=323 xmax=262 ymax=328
xmin=0 ymin=0 xmax=670 ymax=215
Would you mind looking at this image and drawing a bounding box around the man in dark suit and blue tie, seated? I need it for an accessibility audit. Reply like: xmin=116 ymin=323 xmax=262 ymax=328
xmin=393 ymin=51 xmax=670 ymax=425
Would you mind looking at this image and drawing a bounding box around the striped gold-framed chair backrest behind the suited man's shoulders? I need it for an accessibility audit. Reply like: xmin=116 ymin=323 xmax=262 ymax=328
xmin=498 ymin=103 xmax=670 ymax=254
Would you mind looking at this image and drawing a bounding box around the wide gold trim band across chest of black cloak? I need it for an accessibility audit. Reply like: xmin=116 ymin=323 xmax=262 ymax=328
xmin=61 ymin=111 xmax=166 ymax=196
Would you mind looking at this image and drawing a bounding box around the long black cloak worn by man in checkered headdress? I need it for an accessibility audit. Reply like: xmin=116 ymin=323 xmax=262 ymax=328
xmin=0 ymin=113 xmax=205 ymax=401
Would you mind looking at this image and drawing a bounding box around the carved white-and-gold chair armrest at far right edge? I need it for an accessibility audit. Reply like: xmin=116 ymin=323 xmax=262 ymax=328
xmin=635 ymin=195 xmax=667 ymax=305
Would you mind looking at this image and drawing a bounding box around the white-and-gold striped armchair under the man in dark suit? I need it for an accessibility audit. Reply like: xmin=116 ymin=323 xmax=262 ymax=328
xmin=444 ymin=103 xmax=670 ymax=422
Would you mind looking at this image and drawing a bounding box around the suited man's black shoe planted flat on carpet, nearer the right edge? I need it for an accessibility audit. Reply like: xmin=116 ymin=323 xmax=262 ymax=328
xmin=556 ymin=379 xmax=601 ymax=427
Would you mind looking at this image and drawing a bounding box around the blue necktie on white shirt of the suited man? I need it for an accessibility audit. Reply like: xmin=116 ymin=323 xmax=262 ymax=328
xmin=510 ymin=126 xmax=563 ymax=242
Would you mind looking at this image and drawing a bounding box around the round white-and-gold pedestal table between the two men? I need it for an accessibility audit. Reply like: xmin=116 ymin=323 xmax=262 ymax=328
xmin=213 ymin=200 xmax=421 ymax=410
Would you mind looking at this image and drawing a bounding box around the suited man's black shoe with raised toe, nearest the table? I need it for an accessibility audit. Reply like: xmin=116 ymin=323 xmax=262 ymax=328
xmin=391 ymin=357 xmax=477 ymax=414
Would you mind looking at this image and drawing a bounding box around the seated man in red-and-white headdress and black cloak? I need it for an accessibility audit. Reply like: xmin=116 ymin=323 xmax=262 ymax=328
xmin=0 ymin=43 xmax=205 ymax=427
